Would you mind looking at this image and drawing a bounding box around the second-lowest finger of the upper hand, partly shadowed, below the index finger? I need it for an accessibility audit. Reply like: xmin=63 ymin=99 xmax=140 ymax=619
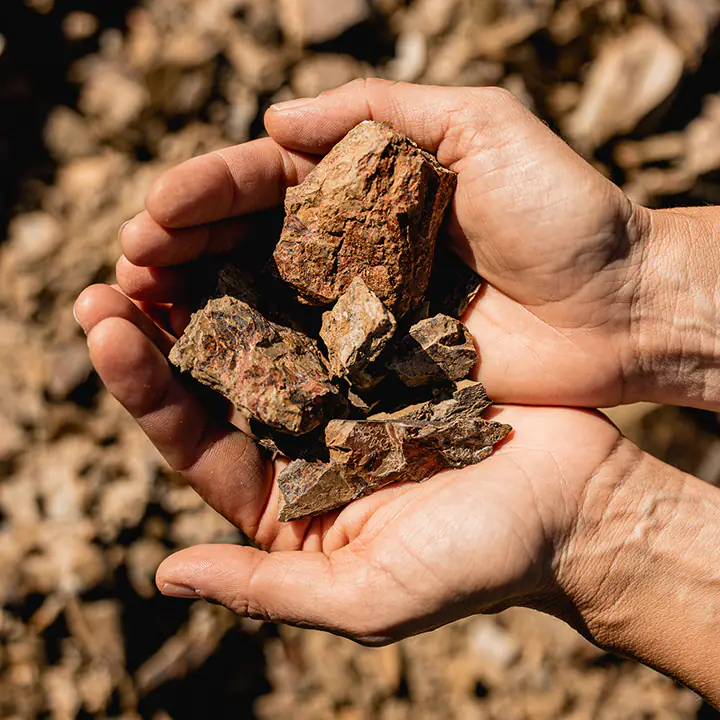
xmin=120 ymin=210 xmax=250 ymax=267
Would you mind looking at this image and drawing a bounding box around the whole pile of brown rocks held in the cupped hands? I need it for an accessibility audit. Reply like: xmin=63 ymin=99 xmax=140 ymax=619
xmin=170 ymin=122 xmax=511 ymax=521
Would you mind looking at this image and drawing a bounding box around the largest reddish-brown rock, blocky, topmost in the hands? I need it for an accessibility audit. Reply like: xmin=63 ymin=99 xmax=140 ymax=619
xmin=274 ymin=122 xmax=457 ymax=319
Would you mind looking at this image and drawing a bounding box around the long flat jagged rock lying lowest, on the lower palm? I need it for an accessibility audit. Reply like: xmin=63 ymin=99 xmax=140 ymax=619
xmin=278 ymin=382 xmax=512 ymax=522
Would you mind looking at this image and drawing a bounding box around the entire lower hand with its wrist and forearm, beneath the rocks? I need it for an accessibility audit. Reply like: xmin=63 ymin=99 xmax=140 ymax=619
xmin=76 ymin=286 xmax=720 ymax=704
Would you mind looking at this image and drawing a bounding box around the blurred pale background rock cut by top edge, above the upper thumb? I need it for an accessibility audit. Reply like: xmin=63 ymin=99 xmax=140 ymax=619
xmin=278 ymin=0 xmax=372 ymax=45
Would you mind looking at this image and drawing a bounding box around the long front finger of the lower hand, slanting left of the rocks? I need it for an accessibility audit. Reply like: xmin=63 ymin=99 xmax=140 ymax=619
xmin=88 ymin=312 xmax=272 ymax=537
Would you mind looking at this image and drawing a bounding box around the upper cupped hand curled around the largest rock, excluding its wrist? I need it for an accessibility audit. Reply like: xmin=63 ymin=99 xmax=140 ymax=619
xmin=118 ymin=80 xmax=649 ymax=407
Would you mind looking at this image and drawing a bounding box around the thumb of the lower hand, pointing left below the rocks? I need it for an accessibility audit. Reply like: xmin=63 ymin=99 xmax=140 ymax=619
xmin=156 ymin=545 xmax=387 ymax=644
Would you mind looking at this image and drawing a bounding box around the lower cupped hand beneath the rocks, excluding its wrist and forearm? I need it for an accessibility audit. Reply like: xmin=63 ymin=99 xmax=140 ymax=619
xmin=76 ymin=286 xmax=621 ymax=644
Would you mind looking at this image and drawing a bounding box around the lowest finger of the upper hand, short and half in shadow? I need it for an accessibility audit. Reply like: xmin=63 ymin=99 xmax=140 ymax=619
xmin=115 ymin=255 xmax=207 ymax=303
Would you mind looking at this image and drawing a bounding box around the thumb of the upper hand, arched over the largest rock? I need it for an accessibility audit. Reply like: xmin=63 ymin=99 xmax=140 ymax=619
xmin=265 ymin=79 xmax=525 ymax=167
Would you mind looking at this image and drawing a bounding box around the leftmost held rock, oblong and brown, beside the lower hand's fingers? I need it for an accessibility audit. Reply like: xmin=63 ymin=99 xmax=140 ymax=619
xmin=170 ymin=297 xmax=347 ymax=435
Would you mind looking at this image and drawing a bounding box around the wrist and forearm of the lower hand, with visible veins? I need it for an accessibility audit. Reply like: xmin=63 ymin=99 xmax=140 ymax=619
xmin=557 ymin=440 xmax=720 ymax=703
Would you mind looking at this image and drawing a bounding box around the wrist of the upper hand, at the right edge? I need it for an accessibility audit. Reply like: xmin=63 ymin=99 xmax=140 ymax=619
xmin=625 ymin=208 xmax=720 ymax=408
